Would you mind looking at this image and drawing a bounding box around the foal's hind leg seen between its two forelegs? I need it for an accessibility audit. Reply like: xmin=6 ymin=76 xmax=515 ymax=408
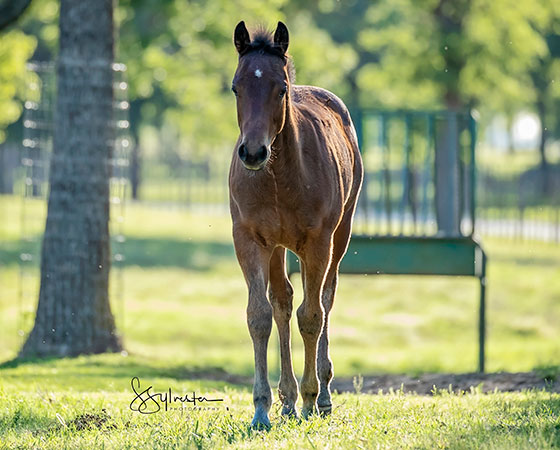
xmin=268 ymin=247 xmax=298 ymax=417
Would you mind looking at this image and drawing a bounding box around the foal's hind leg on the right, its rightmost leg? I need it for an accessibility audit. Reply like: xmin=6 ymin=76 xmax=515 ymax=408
xmin=317 ymin=213 xmax=352 ymax=415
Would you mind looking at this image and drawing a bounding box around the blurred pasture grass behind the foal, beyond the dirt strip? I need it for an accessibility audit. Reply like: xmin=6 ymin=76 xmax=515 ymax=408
xmin=0 ymin=201 xmax=560 ymax=376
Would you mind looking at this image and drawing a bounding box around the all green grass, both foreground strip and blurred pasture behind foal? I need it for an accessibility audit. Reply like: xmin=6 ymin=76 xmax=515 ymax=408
xmin=0 ymin=197 xmax=560 ymax=449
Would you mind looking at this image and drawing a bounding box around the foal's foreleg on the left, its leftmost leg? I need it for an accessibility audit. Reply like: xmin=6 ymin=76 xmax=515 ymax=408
xmin=234 ymin=230 xmax=272 ymax=428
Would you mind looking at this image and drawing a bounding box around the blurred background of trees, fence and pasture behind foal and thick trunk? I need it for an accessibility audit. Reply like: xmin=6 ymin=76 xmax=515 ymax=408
xmin=0 ymin=0 xmax=560 ymax=375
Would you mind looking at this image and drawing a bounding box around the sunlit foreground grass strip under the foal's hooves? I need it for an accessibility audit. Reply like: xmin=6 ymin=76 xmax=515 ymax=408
xmin=0 ymin=364 xmax=560 ymax=449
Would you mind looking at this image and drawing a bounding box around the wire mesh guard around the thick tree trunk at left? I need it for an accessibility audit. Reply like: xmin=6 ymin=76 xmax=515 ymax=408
xmin=11 ymin=63 xmax=130 ymax=340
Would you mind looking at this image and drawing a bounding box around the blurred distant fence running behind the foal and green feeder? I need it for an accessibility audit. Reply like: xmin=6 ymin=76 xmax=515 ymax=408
xmin=128 ymin=132 xmax=560 ymax=244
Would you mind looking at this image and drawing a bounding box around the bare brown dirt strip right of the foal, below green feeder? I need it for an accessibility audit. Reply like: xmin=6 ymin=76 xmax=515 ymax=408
xmin=331 ymin=372 xmax=560 ymax=395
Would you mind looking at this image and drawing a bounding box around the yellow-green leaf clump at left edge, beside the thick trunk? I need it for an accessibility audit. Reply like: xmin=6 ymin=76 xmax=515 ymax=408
xmin=0 ymin=30 xmax=36 ymax=143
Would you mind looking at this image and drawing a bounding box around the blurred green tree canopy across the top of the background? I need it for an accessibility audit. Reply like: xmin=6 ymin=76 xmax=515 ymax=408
xmin=0 ymin=0 xmax=560 ymax=153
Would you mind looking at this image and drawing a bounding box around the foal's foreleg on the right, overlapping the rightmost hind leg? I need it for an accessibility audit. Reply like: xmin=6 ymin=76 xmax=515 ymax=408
xmin=297 ymin=239 xmax=331 ymax=418
